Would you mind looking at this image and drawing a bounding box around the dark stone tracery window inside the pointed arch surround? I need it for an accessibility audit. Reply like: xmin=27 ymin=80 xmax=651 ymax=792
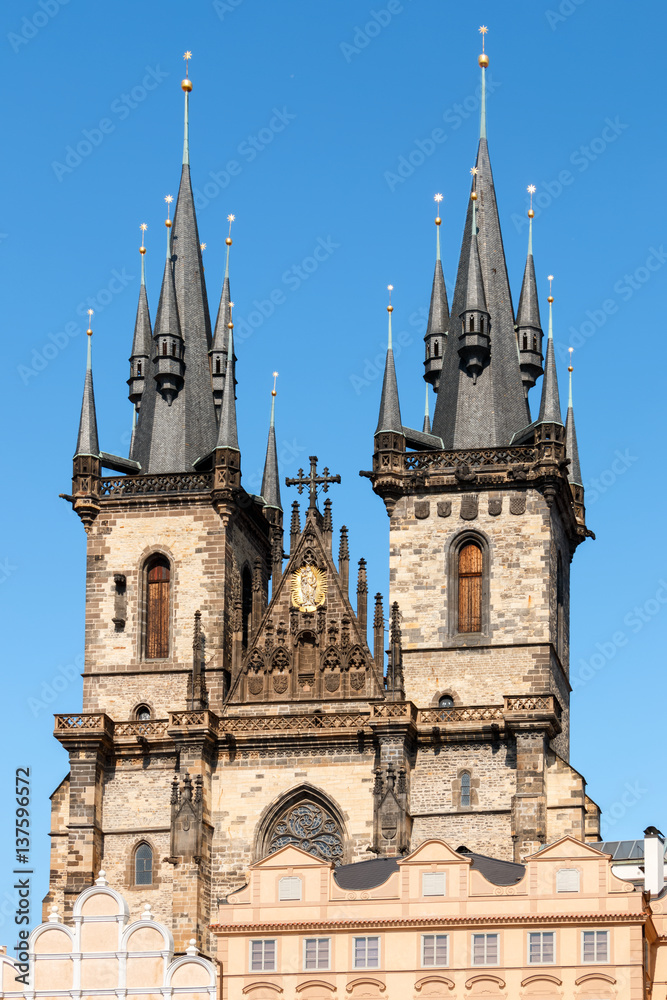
xmin=260 ymin=795 xmax=344 ymax=865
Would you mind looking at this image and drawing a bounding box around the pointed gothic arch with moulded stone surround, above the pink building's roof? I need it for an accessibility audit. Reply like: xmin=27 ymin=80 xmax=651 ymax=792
xmin=254 ymin=784 xmax=349 ymax=865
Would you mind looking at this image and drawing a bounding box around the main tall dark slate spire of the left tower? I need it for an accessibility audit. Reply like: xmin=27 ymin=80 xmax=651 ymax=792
xmin=133 ymin=65 xmax=217 ymax=473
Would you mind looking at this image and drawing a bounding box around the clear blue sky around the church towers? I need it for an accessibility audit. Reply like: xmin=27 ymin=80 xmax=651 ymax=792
xmin=0 ymin=0 xmax=667 ymax=944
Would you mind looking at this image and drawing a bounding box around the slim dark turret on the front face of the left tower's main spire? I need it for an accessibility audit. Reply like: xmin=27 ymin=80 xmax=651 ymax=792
xmin=153 ymin=195 xmax=185 ymax=406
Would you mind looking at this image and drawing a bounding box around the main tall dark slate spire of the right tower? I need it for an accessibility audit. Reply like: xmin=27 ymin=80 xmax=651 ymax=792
xmin=433 ymin=39 xmax=530 ymax=449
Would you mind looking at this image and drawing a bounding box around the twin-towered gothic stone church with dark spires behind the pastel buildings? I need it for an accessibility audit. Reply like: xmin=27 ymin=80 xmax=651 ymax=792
xmin=45 ymin=43 xmax=599 ymax=956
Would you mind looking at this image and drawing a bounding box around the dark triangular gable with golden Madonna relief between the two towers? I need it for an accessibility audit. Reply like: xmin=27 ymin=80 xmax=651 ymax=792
xmin=229 ymin=501 xmax=385 ymax=704
